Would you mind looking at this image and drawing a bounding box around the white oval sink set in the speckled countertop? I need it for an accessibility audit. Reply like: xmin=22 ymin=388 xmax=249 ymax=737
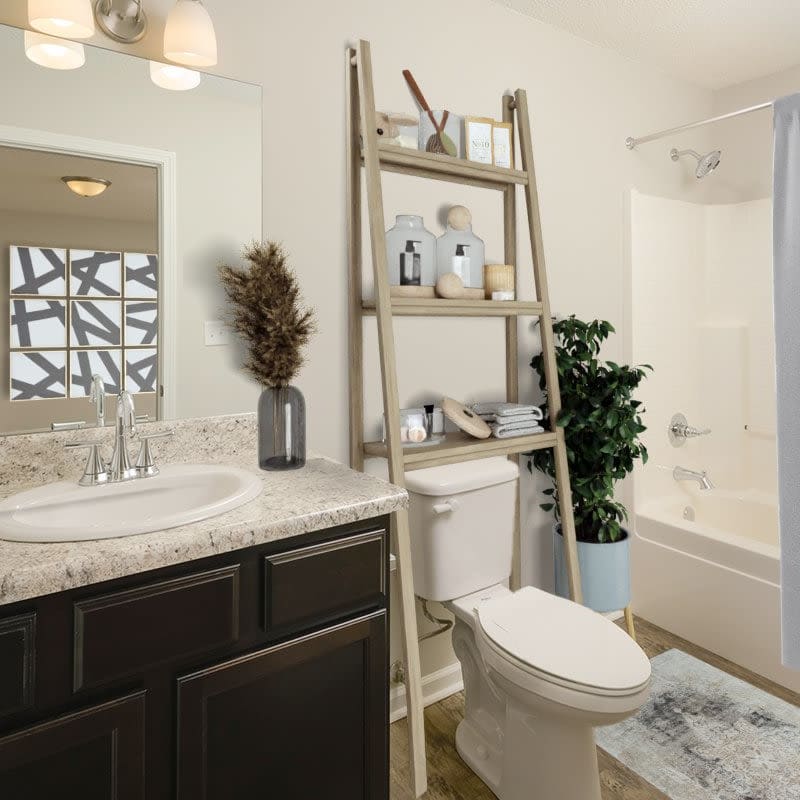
xmin=0 ymin=464 xmax=262 ymax=542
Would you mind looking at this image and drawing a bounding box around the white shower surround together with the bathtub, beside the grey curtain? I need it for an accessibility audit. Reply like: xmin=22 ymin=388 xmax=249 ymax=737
xmin=630 ymin=188 xmax=800 ymax=691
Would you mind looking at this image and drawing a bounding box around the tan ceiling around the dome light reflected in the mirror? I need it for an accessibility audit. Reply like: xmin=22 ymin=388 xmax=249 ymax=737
xmin=0 ymin=147 xmax=158 ymax=223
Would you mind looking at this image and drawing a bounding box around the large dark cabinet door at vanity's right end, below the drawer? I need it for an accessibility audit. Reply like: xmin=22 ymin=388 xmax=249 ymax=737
xmin=178 ymin=611 xmax=388 ymax=800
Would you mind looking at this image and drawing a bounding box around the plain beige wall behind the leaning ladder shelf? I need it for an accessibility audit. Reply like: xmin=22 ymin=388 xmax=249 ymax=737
xmin=0 ymin=0 xmax=712 ymax=688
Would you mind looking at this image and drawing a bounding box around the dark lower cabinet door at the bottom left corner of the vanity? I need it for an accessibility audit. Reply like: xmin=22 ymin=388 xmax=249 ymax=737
xmin=0 ymin=692 xmax=145 ymax=800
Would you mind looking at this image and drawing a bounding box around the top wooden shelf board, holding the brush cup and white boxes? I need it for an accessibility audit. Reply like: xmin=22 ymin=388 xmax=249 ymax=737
xmin=362 ymin=141 xmax=528 ymax=189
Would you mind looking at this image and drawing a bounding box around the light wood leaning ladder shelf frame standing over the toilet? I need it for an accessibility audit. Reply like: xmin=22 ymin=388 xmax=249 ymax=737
xmin=346 ymin=41 xmax=582 ymax=797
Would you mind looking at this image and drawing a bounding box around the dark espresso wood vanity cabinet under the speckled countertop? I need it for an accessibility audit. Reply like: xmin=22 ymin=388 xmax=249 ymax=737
xmin=0 ymin=518 xmax=389 ymax=800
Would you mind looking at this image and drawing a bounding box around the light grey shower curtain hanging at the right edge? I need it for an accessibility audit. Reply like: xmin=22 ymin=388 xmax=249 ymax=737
xmin=772 ymin=94 xmax=800 ymax=669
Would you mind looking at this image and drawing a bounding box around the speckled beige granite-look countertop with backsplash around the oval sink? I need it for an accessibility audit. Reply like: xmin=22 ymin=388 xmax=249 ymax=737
xmin=0 ymin=414 xmax=407 ymax=605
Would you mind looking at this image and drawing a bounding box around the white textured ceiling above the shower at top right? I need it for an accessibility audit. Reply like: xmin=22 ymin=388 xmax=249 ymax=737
xmin=494 ymin=0 xmax=800 ymax=89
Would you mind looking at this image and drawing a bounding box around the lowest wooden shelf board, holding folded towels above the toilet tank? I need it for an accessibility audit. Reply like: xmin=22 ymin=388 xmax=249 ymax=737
xmin=364 ymin=431 xmax=556 ymax=470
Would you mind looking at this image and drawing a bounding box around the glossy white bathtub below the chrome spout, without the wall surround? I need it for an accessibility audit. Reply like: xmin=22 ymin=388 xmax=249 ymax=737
xmin=632 ymin=489 xmax=800 ymax=691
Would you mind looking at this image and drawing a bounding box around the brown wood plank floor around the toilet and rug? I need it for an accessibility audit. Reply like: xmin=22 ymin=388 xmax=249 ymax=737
xmin=390 ymin=618 xmax=800 ymax=800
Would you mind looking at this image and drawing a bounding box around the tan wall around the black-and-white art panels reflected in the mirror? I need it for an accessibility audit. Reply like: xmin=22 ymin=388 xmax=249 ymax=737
xmin=0 ymin=210 xmax=158 ymax=432
